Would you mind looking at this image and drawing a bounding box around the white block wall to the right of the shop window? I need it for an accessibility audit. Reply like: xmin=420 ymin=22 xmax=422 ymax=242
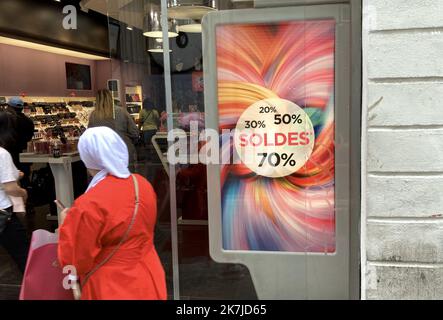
xmin=362 ymin=0 xmax=443 ymax=299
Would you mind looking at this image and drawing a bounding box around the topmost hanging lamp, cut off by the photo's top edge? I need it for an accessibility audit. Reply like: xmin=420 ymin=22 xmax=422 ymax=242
xmin=168 ymin=0 xmax=218 ymax=20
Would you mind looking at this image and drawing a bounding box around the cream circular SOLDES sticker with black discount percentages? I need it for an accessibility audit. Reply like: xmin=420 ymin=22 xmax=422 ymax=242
xmin=234 ymin=98 xmax=315 ymax=178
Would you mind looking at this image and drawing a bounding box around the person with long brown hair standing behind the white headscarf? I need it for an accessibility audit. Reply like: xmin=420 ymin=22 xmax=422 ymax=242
xmin=88 ymin=89 xmax=139 ymax=172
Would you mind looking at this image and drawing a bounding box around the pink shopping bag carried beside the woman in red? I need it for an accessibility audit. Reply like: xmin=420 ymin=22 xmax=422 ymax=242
xmin=20 ymin=230 xmax=74 ymax=300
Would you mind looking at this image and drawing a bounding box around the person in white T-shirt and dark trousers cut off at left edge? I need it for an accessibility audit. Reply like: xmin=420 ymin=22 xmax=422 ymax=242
xmin=0 ymin=109 xmax=29 ymax=273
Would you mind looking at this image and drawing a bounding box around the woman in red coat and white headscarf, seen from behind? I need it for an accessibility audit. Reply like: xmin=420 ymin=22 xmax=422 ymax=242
xmin=58 ymin=127 xmax=167 ymax=300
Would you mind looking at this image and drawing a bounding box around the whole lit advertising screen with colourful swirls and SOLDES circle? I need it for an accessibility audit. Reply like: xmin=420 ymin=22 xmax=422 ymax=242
xmin=216 ymin=19 xmax=336 ymax=253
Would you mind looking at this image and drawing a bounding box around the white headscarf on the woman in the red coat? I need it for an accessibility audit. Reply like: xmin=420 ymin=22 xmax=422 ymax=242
xmin=78 ymin=127 xmax=131 ymax=191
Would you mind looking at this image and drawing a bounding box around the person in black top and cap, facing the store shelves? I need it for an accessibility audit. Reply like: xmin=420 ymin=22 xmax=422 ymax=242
xmin=8 ymin=97 xmax=34 ymax=187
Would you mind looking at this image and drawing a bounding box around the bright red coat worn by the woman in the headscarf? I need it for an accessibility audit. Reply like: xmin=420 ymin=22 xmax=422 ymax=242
xmin=58 ymin=175 xmax=167 ymax=300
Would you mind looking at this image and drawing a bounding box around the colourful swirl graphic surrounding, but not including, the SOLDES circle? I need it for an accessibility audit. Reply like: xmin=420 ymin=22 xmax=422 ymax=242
xmin=217 ymin=20 xmax=335 ymax=253
